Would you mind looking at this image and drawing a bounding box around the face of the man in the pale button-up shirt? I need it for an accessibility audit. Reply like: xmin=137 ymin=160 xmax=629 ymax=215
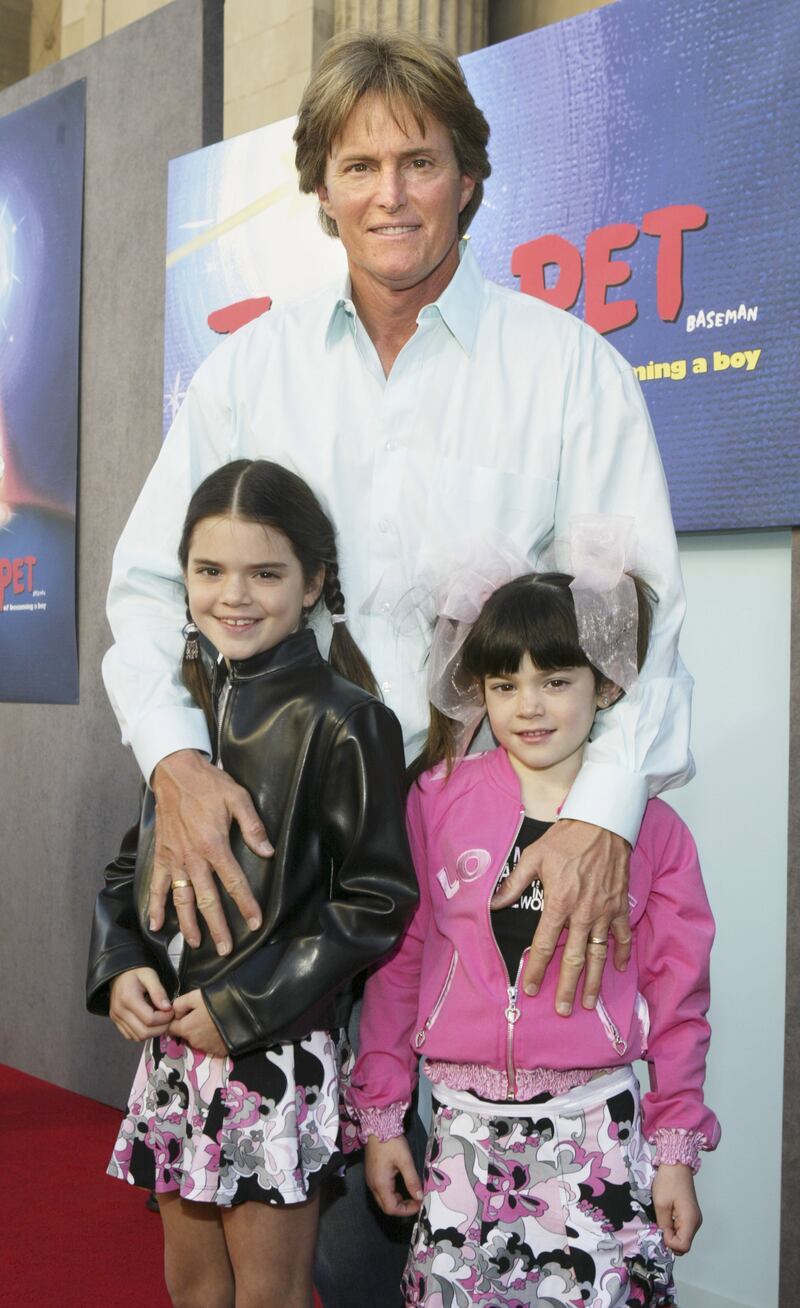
xmin=318 ymin=95 xmax=475 ymax=298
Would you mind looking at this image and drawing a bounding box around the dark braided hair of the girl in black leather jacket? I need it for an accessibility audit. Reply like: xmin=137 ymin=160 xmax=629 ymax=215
xmin=178 ymin=459 xmax=380 ymax=722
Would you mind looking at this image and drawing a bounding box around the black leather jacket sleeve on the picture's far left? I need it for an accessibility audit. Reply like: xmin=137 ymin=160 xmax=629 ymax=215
xmin=86 ymin=823 xmax=169 ymax=1016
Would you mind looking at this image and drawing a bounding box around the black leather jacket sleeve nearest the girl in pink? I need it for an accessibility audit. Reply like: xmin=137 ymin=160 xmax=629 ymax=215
xmin=201 ymin=700 xmax=417 ymax=1053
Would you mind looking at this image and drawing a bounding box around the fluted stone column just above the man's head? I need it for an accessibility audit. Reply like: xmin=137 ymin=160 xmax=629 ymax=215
xmin=336 ymin=0 xmax=489 ymax=55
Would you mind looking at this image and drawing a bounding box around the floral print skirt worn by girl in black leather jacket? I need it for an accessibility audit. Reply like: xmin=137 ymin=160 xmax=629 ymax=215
xmin=108 ymin=1031 xmax=353 ymax=1206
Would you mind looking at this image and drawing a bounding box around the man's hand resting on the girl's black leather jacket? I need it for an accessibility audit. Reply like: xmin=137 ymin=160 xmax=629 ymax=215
xmin=148 ymin=749 xmax=275 ymax=954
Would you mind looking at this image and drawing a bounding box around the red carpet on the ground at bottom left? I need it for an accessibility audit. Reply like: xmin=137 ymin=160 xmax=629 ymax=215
xmin=0 ymin=1065 xmax=322 ymax=1308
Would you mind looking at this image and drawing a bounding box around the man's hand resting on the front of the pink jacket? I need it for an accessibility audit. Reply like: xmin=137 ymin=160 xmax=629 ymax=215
xmin=492 ymin=818 xmax=631 ymax=1018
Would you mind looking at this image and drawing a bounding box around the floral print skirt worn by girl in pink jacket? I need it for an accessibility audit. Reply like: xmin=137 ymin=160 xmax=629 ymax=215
xmin=403 ymin=1069 xmax=676 ymax=1308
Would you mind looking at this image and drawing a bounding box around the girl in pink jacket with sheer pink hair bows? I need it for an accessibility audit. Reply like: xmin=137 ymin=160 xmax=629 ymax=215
xmin=350 ymin=554 xmax=719 ymax=1308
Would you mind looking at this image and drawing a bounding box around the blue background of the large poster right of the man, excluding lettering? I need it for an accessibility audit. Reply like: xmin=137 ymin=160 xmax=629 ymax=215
xmin=461 ymin=0 xmax=800 ymax=531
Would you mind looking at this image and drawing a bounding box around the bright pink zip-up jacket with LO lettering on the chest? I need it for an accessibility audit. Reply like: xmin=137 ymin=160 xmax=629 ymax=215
xmin=349 ymin=748 xmax=720 ymax=1167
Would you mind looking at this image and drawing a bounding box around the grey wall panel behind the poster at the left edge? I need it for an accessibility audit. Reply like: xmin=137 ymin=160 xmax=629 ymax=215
xmin=0 ymin=0 xmax=222 ymax=1103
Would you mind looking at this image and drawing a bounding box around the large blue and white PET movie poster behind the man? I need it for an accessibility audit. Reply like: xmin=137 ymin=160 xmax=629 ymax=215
xmin=165 ymin=0 xmax=800 ymax=531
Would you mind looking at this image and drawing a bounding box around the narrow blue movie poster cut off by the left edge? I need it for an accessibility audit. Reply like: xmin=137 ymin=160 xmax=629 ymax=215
xmin=0 ymin=81 xmax=85 ymax=704
